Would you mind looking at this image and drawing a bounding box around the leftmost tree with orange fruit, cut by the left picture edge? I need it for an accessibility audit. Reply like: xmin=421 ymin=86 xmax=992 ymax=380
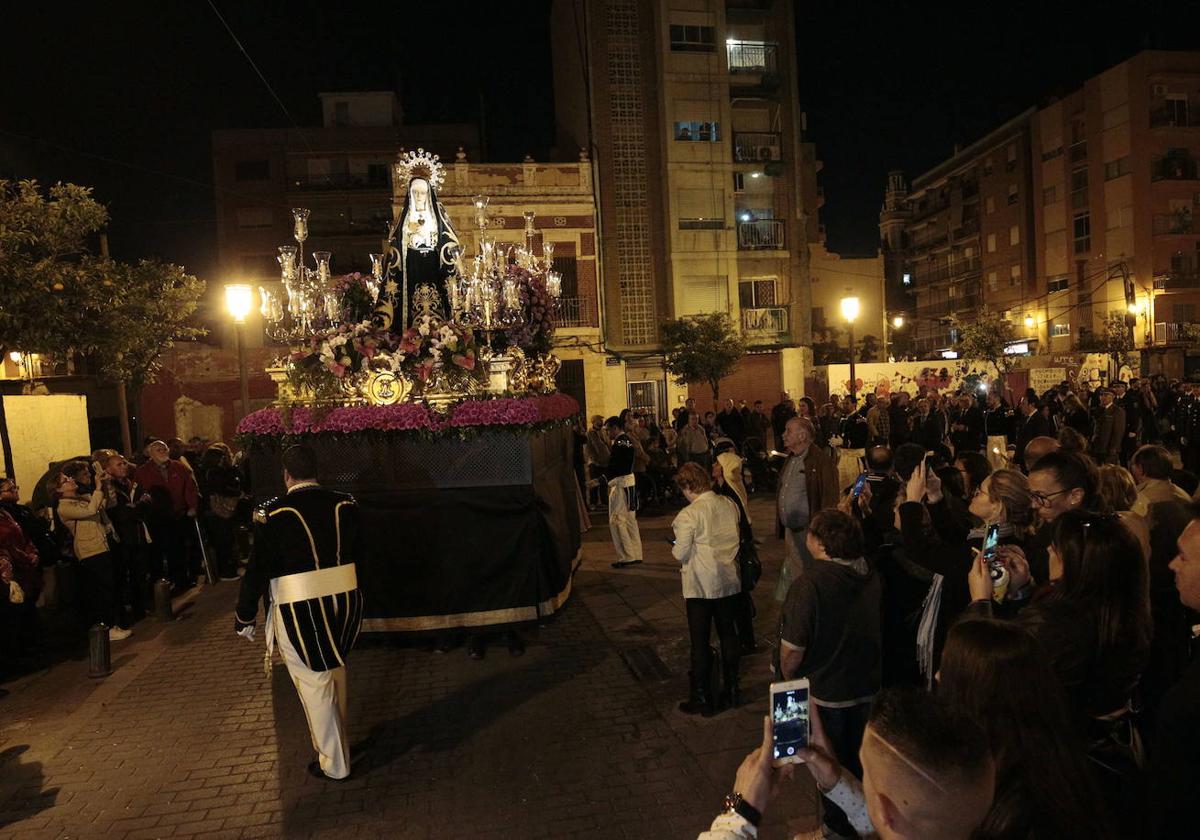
xmin=0 ymin=180 xmax=108 ymax=355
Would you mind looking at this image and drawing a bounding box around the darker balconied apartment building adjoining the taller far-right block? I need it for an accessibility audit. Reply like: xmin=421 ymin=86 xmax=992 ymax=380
xmin=880 ymin=108 xmax=1044 ymax=358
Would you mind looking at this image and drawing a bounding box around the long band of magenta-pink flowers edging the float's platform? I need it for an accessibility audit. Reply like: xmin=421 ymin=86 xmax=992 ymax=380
xmin=238 ymin=394 xmax=580 ymax=446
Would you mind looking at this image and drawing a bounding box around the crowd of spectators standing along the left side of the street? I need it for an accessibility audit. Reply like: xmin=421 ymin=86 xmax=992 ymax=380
xmin=0 ymin=438 xmax=251 ymax=676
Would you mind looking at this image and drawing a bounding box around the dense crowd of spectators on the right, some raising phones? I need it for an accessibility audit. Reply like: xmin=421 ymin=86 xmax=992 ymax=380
xmin=702 ymin=377 xmax=1200 ymax=840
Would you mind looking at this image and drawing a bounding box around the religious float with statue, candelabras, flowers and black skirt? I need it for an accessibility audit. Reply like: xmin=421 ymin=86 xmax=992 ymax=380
xmin=238 ymin=150 xmax=580 ymax=631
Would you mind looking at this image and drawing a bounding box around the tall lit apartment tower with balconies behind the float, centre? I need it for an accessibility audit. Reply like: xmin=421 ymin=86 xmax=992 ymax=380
xmin=552 ymin=0 xmax=820 ymax=414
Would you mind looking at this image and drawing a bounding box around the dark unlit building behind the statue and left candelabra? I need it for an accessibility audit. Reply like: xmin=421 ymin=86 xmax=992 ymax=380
xmin=211 ymin=91 xmax=479 ymax=346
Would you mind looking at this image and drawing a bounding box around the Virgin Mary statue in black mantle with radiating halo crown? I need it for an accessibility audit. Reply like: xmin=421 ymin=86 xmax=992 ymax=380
xmin=376 ymin=149 xmax=461 ymax=332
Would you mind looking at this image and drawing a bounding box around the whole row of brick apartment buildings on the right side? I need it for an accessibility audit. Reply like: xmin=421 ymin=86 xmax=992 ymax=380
xmin=880 ymin=50 xmax=1200 ymax=376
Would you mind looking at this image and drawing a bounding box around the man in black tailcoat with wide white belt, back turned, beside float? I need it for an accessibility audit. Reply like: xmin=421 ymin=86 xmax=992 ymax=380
xmin=234 ymin=445 xmax=364 ymax=779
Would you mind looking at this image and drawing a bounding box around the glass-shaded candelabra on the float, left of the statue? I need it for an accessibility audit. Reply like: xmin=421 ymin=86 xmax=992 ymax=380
xmin=259 ymin=208 xmax=343 ymax=344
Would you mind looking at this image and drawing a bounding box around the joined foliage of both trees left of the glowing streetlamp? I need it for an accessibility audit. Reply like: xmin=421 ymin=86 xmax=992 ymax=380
xmin=0 ymin=180 xmax=204 ymax=385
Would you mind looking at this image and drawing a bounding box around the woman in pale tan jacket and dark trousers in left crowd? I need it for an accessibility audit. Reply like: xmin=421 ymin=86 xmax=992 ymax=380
xmin=54 ymin=462 xmax=132 ymax=641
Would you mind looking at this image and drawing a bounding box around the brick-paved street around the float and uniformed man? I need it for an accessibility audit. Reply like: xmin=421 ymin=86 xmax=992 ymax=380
xmin=0 ymin=499 xmax=815 ymax=840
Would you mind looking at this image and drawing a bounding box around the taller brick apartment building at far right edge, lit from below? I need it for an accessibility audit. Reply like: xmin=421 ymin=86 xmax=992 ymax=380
xmin=1033 ymin=50 xmax=1200 ymax=376
